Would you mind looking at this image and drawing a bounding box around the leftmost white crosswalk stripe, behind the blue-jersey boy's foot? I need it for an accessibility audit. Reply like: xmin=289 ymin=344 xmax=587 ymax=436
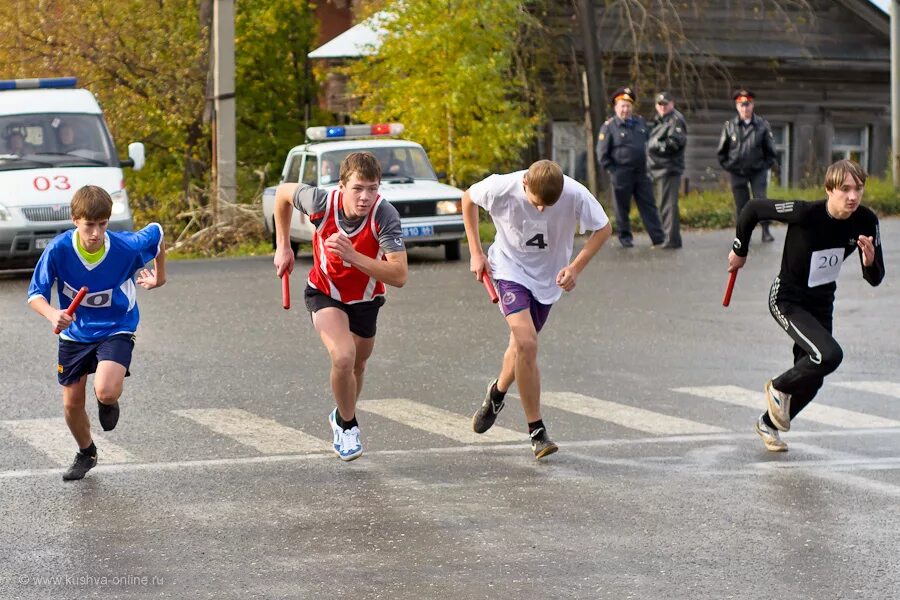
xmin=0 ymin=418 xmax=137 ymax=466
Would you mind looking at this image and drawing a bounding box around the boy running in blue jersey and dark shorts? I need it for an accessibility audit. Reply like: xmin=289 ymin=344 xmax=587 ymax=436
xmin=28 ymin=185 xmax=166 ymax=481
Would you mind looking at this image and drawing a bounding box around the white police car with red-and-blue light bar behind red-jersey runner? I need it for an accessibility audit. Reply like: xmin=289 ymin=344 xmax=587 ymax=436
xmin=262 ymin=123 xmax=465 ymax=260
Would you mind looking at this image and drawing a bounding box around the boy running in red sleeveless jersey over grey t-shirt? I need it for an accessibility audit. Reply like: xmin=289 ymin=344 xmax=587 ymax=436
xmin=274 ymin=152 xmax=408 ymax=461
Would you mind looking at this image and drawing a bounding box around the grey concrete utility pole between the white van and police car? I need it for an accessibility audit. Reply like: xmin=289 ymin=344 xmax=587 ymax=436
xmin=212 ymin=0 xmax=237 ymax=216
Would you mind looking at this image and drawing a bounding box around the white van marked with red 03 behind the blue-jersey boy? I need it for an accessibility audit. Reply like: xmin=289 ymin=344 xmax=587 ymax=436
xmin=0 ymin=77 xmax=144 ymax=268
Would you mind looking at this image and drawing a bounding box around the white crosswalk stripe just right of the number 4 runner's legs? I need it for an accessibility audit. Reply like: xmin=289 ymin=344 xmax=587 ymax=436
xmin=541 ymin=392 xmax=726 ymax=435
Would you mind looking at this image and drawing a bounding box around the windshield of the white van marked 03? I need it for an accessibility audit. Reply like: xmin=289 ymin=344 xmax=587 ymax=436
xmin=0 ymin=113 xmax=118 ymax=170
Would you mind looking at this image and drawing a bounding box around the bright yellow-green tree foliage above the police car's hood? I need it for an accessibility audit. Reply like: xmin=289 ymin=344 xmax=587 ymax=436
xmin=346 ymin=0 xmax=543 ymax=184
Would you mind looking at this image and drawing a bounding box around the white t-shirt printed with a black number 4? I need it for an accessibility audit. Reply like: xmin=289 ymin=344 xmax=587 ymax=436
xmin=469 ymin=171 xmax=609 ymax=304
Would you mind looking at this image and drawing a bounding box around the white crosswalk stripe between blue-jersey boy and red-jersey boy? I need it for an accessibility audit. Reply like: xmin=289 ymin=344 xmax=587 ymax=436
xmin=172 ymin=408 xmax=332 ymax=454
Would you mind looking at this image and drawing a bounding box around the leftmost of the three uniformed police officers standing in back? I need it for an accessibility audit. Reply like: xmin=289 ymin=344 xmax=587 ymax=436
xmin=597 ymin=87 xmax=666 ymax=248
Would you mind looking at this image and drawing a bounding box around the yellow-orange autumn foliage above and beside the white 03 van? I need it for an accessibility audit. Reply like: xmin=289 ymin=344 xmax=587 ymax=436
xmin=0 ymin=0 xmax=209 ymax=227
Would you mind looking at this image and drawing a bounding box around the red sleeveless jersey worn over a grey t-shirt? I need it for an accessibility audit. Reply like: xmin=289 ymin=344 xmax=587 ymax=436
xmin=309 ymin=190 xmax=385 ymax=304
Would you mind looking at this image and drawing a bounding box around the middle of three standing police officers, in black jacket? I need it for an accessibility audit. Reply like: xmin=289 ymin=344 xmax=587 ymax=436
xmin=647 ymin=92 xmax=687 ymax=248
